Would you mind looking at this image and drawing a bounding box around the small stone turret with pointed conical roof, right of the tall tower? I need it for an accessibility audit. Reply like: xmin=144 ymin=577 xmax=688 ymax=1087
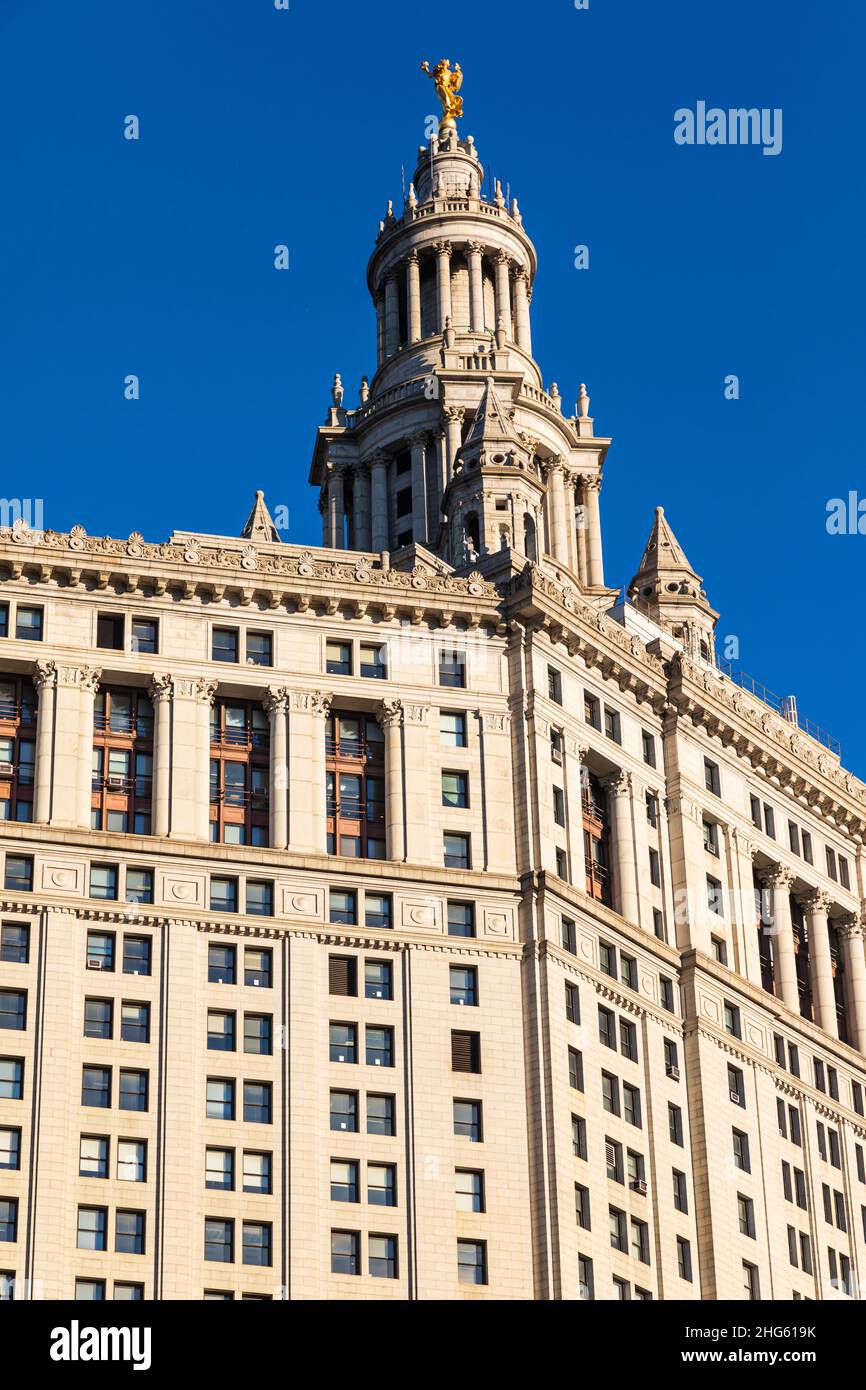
xmin=628 ymin=507 xmax=719 ymax=660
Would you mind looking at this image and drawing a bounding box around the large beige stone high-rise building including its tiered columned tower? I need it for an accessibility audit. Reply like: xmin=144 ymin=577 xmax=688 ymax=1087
xmin=0 ymin=70 xmax=866 ymax=1300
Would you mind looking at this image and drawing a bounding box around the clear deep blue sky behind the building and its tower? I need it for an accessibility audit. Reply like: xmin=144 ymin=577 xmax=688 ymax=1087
xmin=0 ymin=0 xmax=866 ymax=774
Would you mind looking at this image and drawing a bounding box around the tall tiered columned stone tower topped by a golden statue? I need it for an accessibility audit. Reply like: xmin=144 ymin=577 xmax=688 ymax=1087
xmin=310 ymin=61 xmax=610 ymax=595
